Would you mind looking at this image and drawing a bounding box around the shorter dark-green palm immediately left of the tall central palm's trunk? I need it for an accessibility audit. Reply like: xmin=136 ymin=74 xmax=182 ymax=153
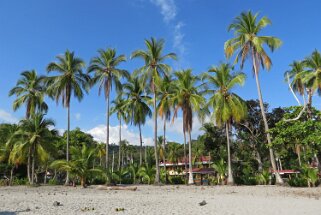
xmin=123 ymin=77 xmax=152 ymax=166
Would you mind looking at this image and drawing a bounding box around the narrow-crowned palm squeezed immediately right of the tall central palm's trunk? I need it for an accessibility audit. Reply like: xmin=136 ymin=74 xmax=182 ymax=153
xmin=158 ymin=75 xmax=173 ymax=174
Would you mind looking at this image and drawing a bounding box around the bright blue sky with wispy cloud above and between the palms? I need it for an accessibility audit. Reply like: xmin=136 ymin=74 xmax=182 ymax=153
xmin=0 ymin=0 xmax=321 ymax=144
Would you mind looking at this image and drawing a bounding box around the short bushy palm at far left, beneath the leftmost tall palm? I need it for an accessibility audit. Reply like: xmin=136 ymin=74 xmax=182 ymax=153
xmin=11 ymin=113 xmax=58 ymax=185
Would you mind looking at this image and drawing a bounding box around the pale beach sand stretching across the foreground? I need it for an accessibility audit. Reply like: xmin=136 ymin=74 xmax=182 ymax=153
xmin=0 ymin=185 xmax=321 ymax=215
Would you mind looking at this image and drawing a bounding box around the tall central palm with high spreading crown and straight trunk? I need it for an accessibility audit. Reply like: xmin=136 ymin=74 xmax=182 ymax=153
xmin=131 ymin=38 xmax=176 ymax=184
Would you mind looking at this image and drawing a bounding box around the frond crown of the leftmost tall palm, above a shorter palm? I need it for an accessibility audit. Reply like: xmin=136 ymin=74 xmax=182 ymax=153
xmin=9 ymin=70 xmax=48 ymax=119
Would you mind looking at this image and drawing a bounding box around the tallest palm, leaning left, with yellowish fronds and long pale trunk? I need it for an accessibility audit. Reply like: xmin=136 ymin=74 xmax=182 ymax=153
xmin=224 ymin=11 xmax=283 ymax=184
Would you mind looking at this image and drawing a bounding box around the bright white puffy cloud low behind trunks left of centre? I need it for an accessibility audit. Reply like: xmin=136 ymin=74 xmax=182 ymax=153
xmin=85 ymin=124 xmax=153 ymax=145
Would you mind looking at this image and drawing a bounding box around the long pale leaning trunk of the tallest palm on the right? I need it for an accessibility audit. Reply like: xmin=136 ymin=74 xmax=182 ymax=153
xmin=252 ymin=51 xmax=283 ymax=184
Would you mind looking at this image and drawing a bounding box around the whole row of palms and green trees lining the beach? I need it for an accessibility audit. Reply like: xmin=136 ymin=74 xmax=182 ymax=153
xmin=1 ymin=11 xmax=321 ymax=185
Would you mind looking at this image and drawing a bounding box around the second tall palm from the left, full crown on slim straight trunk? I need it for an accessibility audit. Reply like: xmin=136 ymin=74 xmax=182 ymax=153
xmin=47 ymin=50 xmax=90 ymax=184
